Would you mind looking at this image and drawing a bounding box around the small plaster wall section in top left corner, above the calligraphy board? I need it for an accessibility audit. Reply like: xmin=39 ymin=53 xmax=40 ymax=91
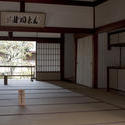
xmin=0 ymin=1 xmax=20 ymax=11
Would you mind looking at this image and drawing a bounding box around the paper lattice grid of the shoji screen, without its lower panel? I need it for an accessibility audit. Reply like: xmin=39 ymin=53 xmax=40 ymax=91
xmin=37 ymin=43 xmax=60 ymax=72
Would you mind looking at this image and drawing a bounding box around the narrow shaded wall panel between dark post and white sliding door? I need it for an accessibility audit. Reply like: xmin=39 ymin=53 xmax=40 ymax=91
xmin=64 ymin=34 xmax=75 ymax=81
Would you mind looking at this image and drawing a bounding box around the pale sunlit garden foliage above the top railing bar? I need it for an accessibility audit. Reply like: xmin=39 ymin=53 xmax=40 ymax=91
xmin=0 ymin=41 xmax=34 ymax=66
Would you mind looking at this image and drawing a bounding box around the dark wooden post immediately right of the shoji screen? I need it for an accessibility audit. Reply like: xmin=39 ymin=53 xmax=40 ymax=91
xmin=60 ymin=34 xmax=65 ymax=80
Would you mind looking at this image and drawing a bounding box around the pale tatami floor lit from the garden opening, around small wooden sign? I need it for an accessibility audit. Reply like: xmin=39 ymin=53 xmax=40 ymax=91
xmin=0 ymin=80 xmax=125 ymax=125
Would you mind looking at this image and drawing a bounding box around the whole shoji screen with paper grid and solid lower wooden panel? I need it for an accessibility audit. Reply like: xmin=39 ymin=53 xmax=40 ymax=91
xmin=36 ymin=40 xmax=61 ymax=80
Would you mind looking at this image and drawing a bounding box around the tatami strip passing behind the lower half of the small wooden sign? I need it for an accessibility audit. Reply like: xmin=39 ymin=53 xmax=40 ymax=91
xmin=0 ymin=97 xmax=100 ymax=107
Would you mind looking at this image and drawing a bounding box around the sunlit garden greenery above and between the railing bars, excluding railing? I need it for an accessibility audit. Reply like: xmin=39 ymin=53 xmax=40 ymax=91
xmin=0 ymin=41 xmax=35 ymax=78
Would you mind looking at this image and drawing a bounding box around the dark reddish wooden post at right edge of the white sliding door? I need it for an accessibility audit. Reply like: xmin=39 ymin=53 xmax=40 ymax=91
xmin=93 ymin=33 xmax=98 ymax=88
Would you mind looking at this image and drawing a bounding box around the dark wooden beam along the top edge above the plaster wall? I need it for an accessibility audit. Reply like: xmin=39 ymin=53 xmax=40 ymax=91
xmin=0 ymin=0 xmax=107 ymax=7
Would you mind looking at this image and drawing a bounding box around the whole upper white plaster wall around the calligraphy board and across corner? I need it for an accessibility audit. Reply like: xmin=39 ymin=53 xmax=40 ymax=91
xmin=0 ymin=0 xmax=125 ymax=28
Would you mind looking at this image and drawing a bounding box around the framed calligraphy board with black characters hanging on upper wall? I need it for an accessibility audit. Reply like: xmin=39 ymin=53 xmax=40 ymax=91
xmin=0 ymin=12 xmax=45 ymax=28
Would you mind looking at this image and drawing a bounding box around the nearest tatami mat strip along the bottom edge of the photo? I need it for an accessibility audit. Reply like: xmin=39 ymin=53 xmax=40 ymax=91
xmin=0 ymin=110 xmax=125 ymax=125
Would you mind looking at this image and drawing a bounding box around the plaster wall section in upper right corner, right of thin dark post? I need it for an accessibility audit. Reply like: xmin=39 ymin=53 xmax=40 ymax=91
xmin=96 ymin=0 xmax=125 ymax=27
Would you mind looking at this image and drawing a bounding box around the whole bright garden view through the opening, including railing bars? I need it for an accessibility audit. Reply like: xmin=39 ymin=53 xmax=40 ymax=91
xmin=0 ymin=40 xmax=36 ymax=78
